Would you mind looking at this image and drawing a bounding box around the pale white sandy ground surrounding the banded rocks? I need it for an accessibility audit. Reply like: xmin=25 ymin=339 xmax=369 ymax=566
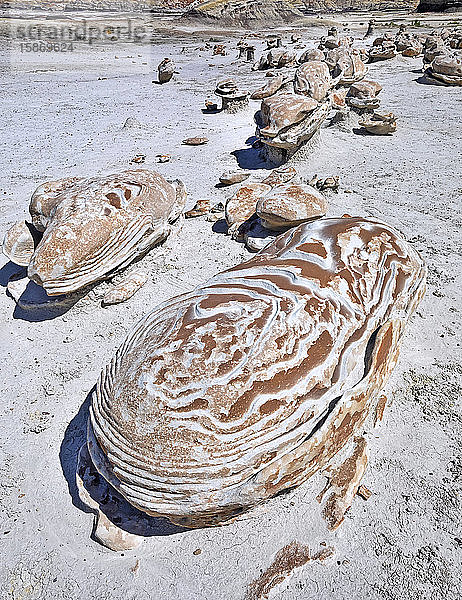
xmin=0 ymin=11 xmax=462 ymax=600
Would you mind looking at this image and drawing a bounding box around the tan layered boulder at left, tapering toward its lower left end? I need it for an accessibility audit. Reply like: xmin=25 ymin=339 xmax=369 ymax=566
xmin=2 ymin=169 xmax=186 ymax=296
